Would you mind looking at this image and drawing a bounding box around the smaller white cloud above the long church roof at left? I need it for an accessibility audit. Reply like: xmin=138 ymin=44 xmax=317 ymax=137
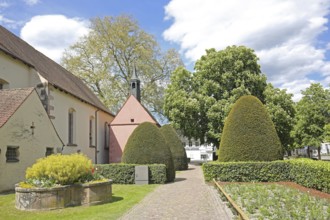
xmin=21 ymin=15 xmax=89 ymax=62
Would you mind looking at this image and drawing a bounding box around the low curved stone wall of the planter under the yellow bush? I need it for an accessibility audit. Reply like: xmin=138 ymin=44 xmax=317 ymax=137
xmin=15 ymin=180 xmax=112 ymax=210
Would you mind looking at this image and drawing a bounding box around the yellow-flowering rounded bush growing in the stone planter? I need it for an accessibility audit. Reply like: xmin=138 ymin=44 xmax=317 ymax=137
xmin=26 ymin=154 xmax=93 ymax=187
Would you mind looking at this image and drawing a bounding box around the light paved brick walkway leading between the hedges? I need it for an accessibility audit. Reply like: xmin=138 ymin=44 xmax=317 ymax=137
xmin=121 ymin=164 xmax=233 ymax=220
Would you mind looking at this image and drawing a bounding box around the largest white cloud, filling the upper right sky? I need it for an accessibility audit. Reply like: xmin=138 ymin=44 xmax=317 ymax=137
xmin=163 ymin=0 xmax=330 ymax=99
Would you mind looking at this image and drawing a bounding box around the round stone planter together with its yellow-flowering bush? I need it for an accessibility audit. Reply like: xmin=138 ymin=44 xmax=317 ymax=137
xmin=15 ymin=154 xmax=112 ymax=210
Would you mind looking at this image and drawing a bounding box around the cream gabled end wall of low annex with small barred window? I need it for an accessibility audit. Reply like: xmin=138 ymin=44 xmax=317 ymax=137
xmin=0 ymin=91 xmax=62 ymax=192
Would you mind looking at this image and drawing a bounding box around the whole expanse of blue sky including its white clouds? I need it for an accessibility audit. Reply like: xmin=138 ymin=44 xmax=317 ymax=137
xmin=0 ymin=0 xmax=330 ymax=100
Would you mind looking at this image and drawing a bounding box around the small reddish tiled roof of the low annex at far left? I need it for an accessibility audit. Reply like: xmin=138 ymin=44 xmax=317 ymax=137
xmin=0 ymin=88 xmax=34 ymax=128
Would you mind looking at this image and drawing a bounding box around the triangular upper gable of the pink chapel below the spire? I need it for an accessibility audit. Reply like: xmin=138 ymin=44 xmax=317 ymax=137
xmin=110 ymin=95 xmax=160 ymax=126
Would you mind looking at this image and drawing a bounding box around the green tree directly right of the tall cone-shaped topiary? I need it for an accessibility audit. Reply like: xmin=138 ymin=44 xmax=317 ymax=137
xmin=264 ymin=83 xmax=295 ymax=151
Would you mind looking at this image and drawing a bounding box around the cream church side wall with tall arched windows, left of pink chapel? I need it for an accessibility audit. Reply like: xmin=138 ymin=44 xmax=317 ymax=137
xmin=51 ymin=88 xmax=113 ymax=163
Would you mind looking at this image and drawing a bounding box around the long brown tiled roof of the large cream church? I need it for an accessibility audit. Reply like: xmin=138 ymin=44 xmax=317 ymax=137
xmin=0 ymin=25 xmax=113 ymax=115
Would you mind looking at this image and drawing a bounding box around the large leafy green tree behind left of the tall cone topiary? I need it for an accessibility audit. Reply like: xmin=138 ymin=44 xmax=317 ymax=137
xmin=164 ymin=46 xmax=266 ymax=146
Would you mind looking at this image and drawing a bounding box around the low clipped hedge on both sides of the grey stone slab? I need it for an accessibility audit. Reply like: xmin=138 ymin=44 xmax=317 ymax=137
xmin=95 ymin=164 xmax=166 ymax=184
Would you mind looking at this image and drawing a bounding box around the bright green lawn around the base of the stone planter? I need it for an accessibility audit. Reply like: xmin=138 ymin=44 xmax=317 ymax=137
xmin=0 ymin=184 xmax=157 ymax=220
